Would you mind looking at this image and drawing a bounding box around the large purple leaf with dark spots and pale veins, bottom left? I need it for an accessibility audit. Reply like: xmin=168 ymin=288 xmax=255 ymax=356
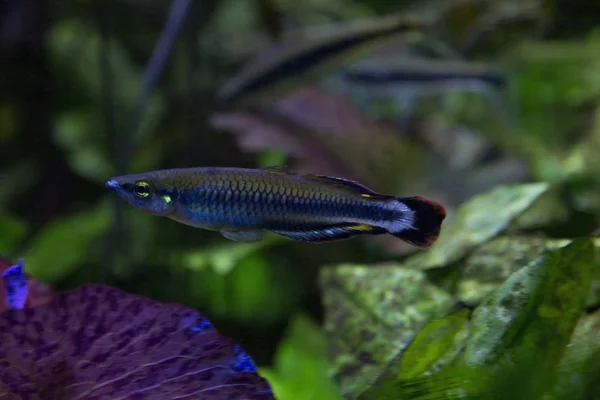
xmin=0 ymin=285 xmax=274 ymax=400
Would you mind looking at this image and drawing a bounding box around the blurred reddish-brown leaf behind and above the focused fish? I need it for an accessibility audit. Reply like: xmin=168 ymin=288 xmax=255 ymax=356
xmin=212 ymin=88 xmax=424 ymax=193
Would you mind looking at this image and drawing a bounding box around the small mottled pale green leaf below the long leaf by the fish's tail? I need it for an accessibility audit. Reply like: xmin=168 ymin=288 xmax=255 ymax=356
xmin=456 ymin=236 xmax=571 ymax=306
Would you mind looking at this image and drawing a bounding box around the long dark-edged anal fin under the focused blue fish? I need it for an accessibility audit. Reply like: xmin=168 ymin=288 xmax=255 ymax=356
xmin=271 ymin=224 xmax=386 ymax=243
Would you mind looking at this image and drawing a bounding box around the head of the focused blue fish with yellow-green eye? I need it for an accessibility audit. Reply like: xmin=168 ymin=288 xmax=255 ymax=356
xmin=106 ymin=172 xmax=179 ymax=216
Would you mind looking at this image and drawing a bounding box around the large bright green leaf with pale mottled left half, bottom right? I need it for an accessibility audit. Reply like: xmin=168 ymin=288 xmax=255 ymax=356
xmin=364 ymin=239 xmax=595 ymax=400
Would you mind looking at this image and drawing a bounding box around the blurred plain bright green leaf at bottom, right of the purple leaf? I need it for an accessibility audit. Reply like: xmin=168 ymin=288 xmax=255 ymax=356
xmin=260 ymin=314 xmax=342 ymax=400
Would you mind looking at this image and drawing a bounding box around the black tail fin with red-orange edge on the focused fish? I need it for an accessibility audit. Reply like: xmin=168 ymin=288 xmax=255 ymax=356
xmin=388 ymin=196 xmax=446 ymax=248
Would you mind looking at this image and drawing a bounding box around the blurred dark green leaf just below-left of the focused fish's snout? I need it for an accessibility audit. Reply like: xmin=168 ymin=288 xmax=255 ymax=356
xmin=24 ymin=201 xmax=110 ymax=282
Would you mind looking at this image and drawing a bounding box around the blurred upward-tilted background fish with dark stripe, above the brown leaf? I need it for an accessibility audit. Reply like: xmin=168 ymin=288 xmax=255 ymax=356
xmin=217 ymin=14 xmax=427 ymax=105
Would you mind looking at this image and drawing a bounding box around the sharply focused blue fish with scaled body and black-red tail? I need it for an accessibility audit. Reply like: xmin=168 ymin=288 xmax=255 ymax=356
xmin=106 ymin=166 xmax=446 ymax=248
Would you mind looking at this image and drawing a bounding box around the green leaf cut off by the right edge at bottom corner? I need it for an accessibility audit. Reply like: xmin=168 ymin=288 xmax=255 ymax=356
xmin=553 ymin=311 xmax=600 ymax=400
